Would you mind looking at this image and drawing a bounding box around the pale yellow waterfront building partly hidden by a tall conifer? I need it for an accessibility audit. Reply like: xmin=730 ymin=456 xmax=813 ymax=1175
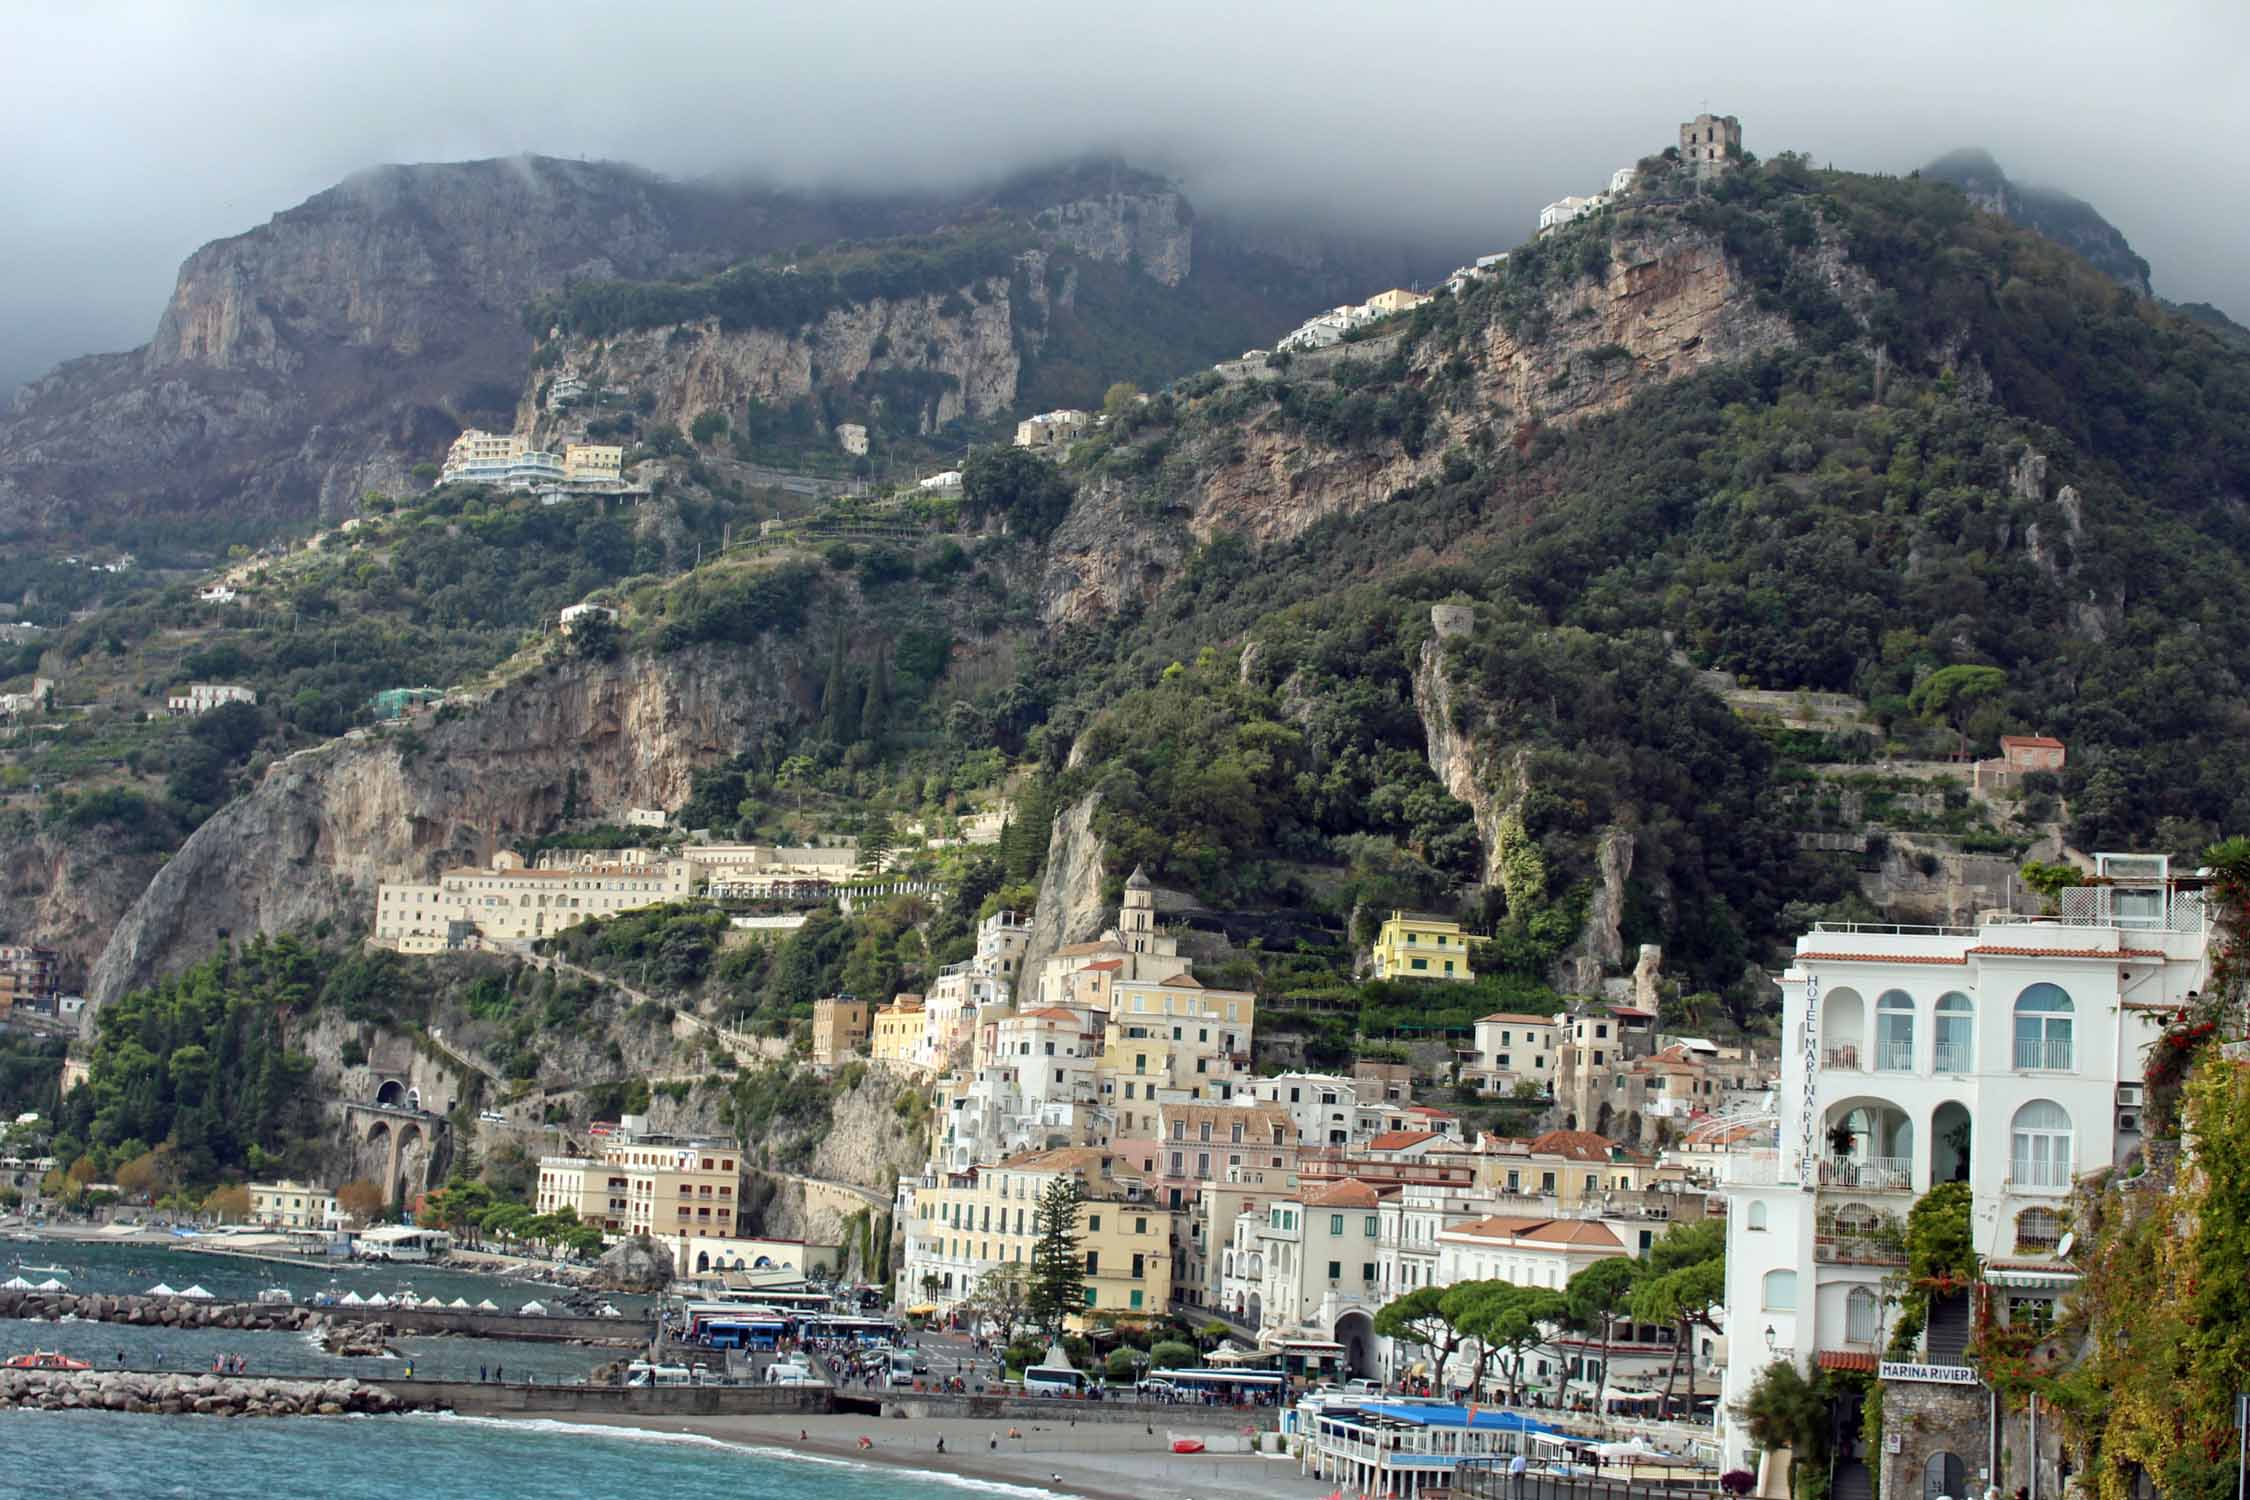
xmin=898 ymin=1147 xmax=1172 ymax=1327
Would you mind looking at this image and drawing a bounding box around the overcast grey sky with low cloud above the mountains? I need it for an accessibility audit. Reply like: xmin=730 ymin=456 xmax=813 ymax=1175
xmin=13 ymin=0 xmax=2250 ymax=391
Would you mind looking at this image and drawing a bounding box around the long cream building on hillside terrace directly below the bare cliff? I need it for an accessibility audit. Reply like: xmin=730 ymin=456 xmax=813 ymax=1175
xmin=371 ymin=855 xmax=695 ymax=954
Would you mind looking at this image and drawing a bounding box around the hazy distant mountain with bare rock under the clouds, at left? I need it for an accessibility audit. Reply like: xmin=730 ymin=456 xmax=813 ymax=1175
xmin=0 ymin=157 xmax=1404 ymax=542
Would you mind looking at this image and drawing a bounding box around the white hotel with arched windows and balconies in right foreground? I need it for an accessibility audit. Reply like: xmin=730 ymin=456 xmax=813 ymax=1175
xmin=1721 ymin=855 xmax=2210 ymax=1466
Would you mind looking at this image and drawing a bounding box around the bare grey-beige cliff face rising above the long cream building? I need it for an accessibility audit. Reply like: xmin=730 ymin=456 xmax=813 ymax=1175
xmin=88 ymin=641 xmax=817 ymax=1003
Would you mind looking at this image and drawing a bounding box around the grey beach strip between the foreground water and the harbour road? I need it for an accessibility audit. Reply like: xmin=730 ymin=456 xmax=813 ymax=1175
xmin=488 ymin=1412 xmax=1332 ymax=1500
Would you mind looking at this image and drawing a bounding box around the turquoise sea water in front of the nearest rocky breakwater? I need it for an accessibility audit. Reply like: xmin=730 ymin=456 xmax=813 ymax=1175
xmin=0 ymin=1412 xmax=1071 ymax=1500
